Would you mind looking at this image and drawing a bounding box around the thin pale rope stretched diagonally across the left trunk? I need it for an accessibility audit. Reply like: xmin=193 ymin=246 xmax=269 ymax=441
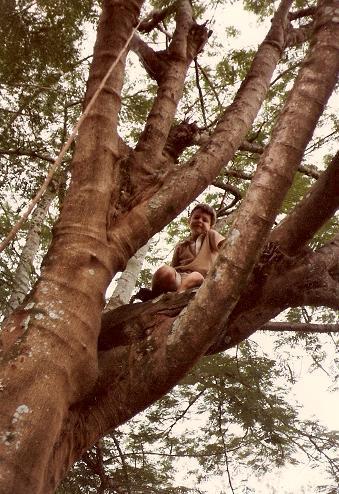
xmin=0 ymin=20 xmax=141 ymax=252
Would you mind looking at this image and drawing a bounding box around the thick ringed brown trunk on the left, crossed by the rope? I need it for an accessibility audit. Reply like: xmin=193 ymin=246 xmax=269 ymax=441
xmin=0 ymin=0 xmax=142 ymax=494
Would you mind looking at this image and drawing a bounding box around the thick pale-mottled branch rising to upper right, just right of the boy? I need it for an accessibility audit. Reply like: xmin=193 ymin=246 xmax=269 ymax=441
xmin=205 ymin=0 xmax=339 ymax=348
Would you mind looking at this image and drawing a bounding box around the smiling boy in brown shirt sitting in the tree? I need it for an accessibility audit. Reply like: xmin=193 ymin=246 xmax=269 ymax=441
xmin=152 ymin=204 xmax=224 ymax=297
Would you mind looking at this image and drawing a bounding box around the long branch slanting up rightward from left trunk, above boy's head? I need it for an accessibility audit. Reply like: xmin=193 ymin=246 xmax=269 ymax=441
xmin=108 ymin=3 xmax=294 ymax=269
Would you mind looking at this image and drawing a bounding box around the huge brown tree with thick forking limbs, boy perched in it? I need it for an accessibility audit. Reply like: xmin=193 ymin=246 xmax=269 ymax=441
xmin=0 ymin=0 xmax=339 ymax=494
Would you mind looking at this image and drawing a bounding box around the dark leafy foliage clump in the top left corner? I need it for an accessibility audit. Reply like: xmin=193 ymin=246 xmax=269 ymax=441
xmin=0 ymin=0 xmax=95 ymax=86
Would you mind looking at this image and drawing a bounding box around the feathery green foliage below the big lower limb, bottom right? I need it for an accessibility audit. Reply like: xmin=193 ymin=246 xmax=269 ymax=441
xmin=58 ymin=342 xmax=338 ymax=494
